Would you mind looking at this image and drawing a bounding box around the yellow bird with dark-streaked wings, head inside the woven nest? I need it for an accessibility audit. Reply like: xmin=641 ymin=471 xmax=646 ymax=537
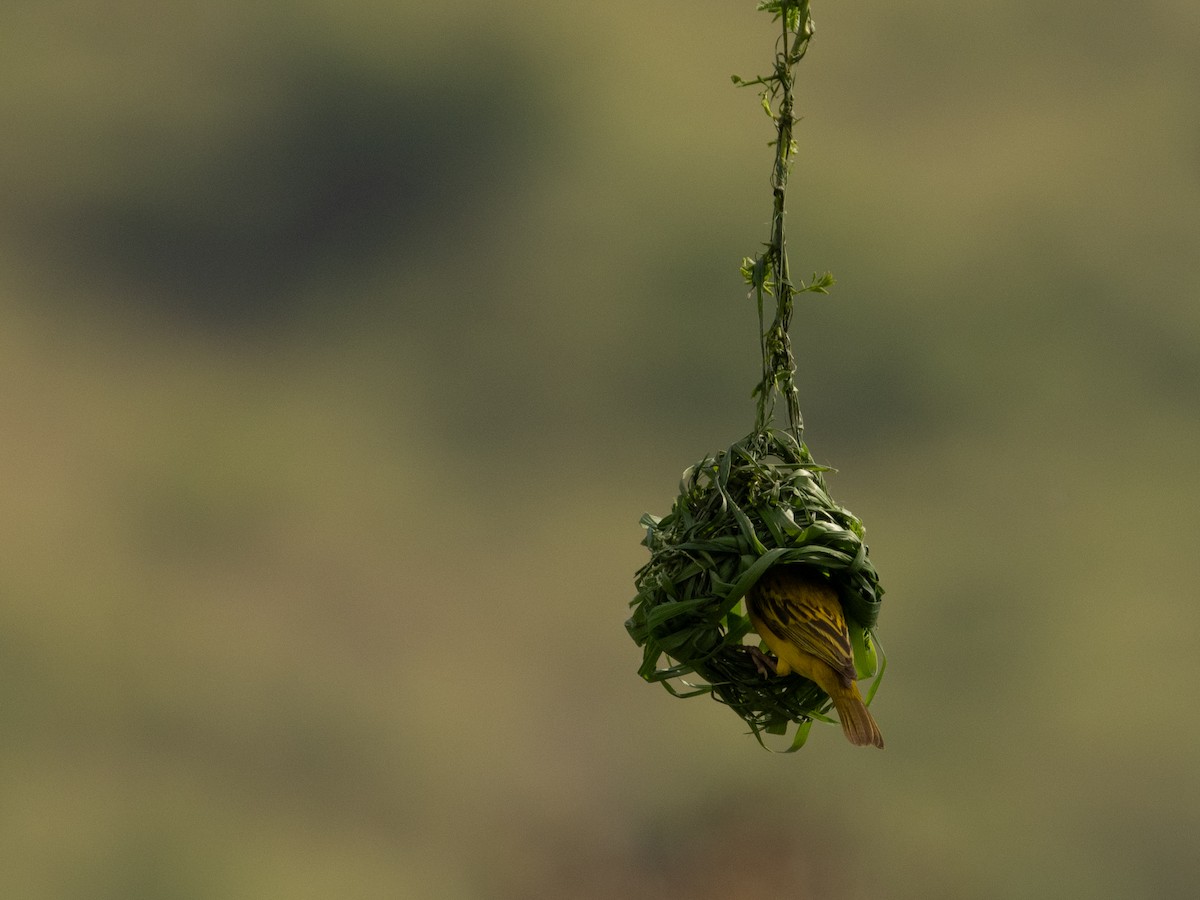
xmin=746 ymin=565 xmax=883 ymax=748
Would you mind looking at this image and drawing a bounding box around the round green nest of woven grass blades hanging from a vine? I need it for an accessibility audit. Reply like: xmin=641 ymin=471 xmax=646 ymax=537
xmin=625 ymin=428 xmax=883 ymax=749
